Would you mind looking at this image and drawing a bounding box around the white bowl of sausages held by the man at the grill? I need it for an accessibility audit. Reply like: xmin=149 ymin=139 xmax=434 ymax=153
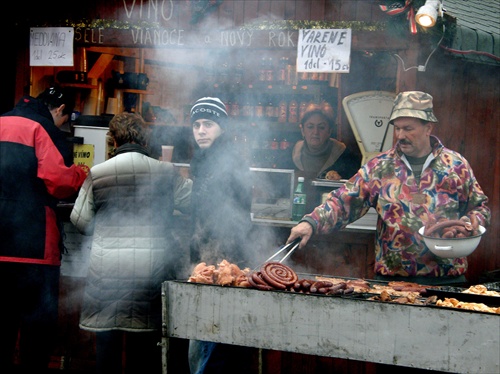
xmin=418 ymin=225 xmax=486 ymax=258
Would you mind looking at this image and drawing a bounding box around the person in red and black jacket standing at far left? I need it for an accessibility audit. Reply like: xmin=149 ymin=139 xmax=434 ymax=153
xmin=0 ymin=87 xmax=86 ymax=373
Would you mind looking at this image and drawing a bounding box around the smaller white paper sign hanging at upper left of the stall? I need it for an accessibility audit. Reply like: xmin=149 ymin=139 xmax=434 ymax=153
xmin=30 ymin=27 xmax=75 ymax=66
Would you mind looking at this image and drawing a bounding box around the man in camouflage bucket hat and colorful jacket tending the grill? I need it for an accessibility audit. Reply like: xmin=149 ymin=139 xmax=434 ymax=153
xmin=287 ymin=91 xmax=491 ymax=285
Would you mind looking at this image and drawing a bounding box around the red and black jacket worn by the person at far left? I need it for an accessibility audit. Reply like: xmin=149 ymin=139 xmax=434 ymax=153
xmin=0 ymin=96 xmax=86 ymax=265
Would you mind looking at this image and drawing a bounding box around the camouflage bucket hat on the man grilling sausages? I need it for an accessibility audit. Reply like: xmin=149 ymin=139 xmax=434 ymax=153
xmin=389 ymin=91 xmax=438 ymax=123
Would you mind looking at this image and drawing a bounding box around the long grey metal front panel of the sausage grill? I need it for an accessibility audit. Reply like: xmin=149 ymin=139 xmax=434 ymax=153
xmin=162 ymin=281 xmax=500 ymax=374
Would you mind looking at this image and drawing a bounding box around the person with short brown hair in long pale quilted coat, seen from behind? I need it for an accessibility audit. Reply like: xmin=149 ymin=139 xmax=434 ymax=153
xmin=71 ymin=113 xmax=192 ymax=374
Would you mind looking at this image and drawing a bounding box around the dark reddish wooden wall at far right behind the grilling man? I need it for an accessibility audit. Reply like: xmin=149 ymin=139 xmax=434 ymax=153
xmin=415 ymin=50 xmax=500 ymax=282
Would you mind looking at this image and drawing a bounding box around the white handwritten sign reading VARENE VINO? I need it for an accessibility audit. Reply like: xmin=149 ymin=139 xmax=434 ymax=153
xmin=297 ymin=29 xmax=351 ymax=73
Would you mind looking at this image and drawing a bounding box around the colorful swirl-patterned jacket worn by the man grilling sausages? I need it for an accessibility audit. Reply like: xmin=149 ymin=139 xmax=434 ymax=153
xmin=303 ymin=136 xmax=491 ymax=277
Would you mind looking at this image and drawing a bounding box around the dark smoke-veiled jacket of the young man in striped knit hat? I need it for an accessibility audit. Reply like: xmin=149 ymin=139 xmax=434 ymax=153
xmin=191 ymin=133 xmax=252 ymax=267
